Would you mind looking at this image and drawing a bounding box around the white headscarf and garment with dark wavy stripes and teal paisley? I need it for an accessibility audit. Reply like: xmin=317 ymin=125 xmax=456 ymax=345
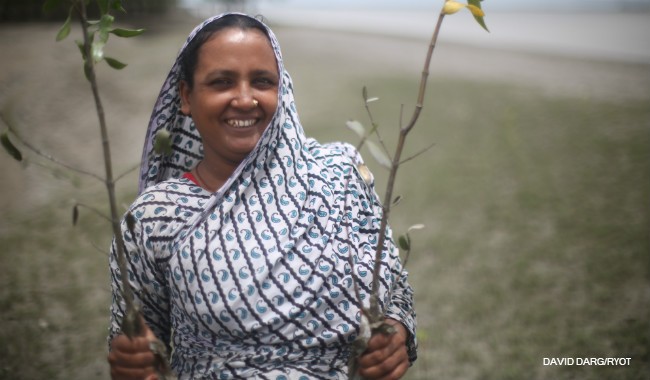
xmin=109 ymin=11 xmax=416 ymax=380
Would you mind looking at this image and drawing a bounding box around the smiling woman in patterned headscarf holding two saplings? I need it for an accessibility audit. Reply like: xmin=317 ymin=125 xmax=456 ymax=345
xmin=109 ymin=14 xmax=416 ymax=379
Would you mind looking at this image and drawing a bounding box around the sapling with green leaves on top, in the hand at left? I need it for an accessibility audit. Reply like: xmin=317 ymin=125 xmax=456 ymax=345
xmin=0 ymin=0 xmax=171 ymax=379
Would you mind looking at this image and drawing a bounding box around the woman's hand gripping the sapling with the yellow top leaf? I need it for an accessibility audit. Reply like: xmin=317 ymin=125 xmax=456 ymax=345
xmin=358 ymin=319 xmax=409 ymax=380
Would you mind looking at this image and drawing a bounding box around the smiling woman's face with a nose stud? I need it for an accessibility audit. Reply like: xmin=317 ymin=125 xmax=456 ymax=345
xmin=180 ymin=28 xmax=280 ymax=165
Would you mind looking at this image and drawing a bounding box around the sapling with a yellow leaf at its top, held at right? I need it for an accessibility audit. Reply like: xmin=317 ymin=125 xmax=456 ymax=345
xmin=347 ymin=0 xmax=488 ymax=378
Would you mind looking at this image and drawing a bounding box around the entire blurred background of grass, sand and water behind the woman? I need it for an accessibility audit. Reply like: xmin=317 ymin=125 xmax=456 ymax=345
xmin=0 ymin=0 xmax=650 ymax=379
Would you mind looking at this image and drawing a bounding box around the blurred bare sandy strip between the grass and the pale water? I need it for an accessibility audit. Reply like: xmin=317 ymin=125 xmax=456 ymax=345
xmin=0 ymin=9 xmax=650 ymax=214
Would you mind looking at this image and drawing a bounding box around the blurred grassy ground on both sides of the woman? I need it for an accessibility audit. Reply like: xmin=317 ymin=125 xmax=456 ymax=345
xmin=0 ymin=11 xmax=650 ymax=380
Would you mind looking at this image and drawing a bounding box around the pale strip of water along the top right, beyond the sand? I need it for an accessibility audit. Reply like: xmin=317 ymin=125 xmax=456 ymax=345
xmin=260 ymin=7 xmax=650 ymax=63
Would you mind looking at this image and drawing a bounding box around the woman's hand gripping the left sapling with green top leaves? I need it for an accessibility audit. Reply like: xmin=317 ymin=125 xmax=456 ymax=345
xmin=108 ymin=323 xmax=157 ymax=380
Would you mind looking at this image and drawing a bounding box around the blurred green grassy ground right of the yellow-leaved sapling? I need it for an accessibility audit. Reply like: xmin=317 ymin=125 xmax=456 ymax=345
xmin=298 ymin=72 xmax=650 ymax=379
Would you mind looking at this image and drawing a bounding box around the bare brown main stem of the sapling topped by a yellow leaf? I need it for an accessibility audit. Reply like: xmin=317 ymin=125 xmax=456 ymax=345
xmin=368 ymin=11 xmax=445 ymax=324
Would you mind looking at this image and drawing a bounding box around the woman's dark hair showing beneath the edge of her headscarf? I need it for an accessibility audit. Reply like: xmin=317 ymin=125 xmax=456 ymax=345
xmin=180 ymin=14 xmax=268 ymax=88
